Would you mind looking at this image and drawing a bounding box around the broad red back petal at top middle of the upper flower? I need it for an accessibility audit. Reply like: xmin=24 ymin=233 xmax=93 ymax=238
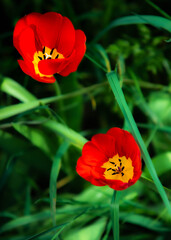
xmin=36 ymin=12 xmax=63 ymax=49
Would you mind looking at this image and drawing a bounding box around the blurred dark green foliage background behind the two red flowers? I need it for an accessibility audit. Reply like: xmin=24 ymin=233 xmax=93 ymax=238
xmin=0 ymin=0 xmax=171 ymax=240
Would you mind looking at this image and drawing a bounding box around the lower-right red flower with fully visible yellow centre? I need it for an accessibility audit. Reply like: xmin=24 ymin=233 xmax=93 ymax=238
xmin=76 ymin=128 xmax=141 ymax=190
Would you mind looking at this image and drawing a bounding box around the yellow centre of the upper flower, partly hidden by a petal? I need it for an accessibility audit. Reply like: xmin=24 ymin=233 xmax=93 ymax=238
xmin=32 ymin=47 xmax=64 ymax=77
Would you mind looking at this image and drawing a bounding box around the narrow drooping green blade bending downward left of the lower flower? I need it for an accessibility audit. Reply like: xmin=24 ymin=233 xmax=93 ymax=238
xmin=49 ymin=142 xmax=69 ymax=226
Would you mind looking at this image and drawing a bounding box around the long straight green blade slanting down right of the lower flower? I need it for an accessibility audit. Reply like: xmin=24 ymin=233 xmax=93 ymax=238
xmin=106 ymin=72 xmax=171 ymax=215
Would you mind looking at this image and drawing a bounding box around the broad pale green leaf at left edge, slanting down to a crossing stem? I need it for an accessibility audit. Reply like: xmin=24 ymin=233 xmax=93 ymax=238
xmin=0 ymin=77 xmax=36 ymax=102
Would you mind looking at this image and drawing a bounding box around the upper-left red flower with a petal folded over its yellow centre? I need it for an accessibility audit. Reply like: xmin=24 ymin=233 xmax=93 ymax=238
xmin=13 ymin=12 xmax=86 ymax=83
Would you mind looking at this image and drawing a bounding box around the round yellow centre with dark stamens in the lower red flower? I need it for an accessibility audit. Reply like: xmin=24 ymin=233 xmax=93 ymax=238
xmin=101 ymin=154 xmax=134 ymax=183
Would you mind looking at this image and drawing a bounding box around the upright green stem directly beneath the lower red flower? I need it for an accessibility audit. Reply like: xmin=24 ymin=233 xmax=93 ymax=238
xmin=111 ymin=190 xmax=119 ymax=240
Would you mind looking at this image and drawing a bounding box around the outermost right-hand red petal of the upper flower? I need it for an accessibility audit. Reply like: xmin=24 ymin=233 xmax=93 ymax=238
xmin=60 ymin=30 xmax=86 ymax=77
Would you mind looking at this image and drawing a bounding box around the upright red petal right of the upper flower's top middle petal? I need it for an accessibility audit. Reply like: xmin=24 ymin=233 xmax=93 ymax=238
xmin=56 ymin=17 xmax=75 ymax=57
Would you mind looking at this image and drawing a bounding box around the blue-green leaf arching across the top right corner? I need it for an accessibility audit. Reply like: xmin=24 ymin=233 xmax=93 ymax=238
xmin=93 ymin=15 xmax=171 ymax=42
